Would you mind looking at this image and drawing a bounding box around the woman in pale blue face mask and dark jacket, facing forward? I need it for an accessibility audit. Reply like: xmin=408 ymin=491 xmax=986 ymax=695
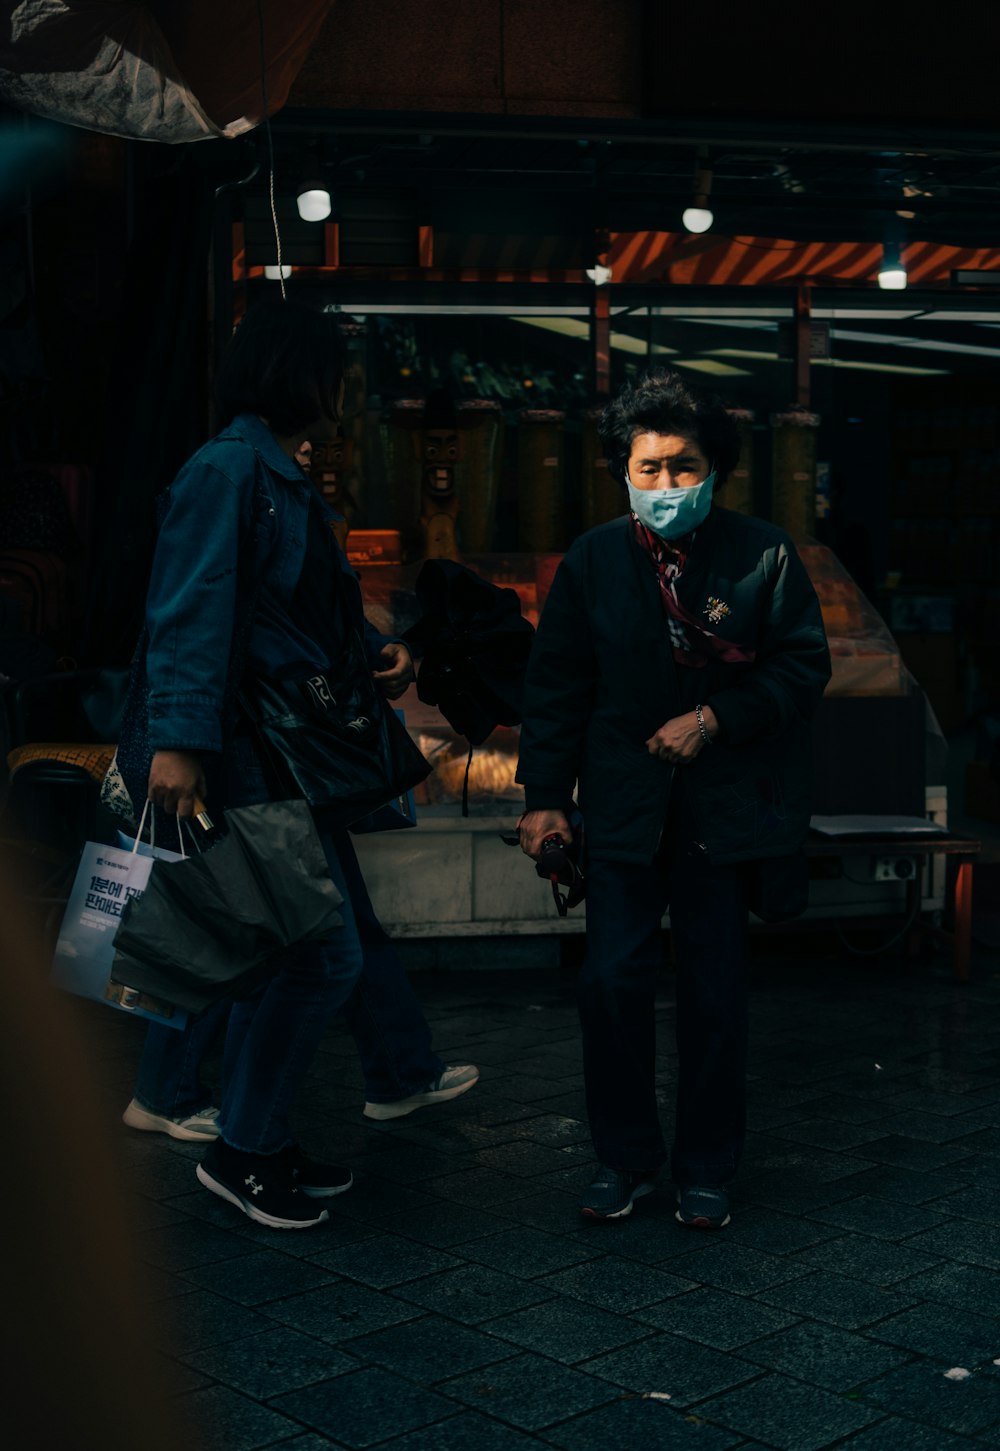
xmin=518 ymin=370 xmax=830 ymax=1229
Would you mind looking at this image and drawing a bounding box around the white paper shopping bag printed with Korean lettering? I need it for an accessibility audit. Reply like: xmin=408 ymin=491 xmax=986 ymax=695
xmin=52 ymin=801 xmax=189 ymax=1029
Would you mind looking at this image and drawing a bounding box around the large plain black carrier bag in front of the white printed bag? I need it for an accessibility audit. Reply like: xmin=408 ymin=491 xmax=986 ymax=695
xmin=112 ymin=801 xmax=343 ymax=1013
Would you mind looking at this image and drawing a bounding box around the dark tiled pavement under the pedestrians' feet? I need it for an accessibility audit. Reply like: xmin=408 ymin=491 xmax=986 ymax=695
xmin=80 ymin=955 xmax=1000 ymax=1451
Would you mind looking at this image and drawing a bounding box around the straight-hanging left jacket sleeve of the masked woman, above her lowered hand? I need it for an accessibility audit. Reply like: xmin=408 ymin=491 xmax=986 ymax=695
xmin=515 ymin=556 xmax=598 ymax=811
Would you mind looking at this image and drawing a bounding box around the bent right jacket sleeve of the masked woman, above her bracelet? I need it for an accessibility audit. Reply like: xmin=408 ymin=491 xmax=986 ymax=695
xmin=705 ymin=543 xmax=830 ymax=746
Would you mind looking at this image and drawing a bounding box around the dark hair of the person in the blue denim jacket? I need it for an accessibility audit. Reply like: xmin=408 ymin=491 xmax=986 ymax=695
xmin=215 ymin=302 xmax=345 ymax=437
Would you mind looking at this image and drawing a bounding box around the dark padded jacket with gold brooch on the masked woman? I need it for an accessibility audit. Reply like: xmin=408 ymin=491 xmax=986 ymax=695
xmin=517 ymin=506 xmax=830 ymax=863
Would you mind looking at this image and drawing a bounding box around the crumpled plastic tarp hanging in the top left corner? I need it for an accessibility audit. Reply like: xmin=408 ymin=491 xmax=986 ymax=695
xmin=0 ymin=0 xmax=332 ymax=142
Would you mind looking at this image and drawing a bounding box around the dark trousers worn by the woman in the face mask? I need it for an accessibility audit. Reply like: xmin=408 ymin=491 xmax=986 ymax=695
xmin=579 ymin=794 xmax=747 ymax=1187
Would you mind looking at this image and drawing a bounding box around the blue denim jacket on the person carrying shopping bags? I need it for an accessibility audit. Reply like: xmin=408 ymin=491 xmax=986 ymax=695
xmin=145 ymin=414 xmax=389 ymax=752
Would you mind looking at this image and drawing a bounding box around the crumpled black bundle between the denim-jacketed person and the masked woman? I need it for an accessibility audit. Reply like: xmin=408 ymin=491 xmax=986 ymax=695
xmin=405 ymin=559 xmax=534 ymax=746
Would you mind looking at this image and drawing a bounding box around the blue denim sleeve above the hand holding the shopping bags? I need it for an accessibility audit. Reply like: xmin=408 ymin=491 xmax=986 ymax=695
xmin=147 ymin=456 xmax=245 ymax=752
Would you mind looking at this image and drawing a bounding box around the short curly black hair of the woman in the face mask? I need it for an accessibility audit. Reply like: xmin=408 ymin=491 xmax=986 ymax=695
xmin=598 ymin=367 xmax=740 ymax=485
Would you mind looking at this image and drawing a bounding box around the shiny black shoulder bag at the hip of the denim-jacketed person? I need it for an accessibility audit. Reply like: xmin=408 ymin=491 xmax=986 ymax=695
xmin=239 ymin=634 xmax=431 ymax=824
